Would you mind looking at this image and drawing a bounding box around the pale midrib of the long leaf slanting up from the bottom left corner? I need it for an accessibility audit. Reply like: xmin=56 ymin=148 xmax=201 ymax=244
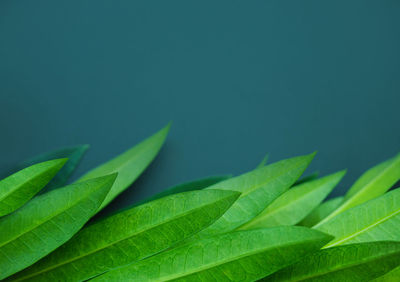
xmin=16 ymin=195 xmax=233 ymax=281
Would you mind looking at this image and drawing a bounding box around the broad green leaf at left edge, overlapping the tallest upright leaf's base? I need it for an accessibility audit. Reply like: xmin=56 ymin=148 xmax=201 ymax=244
xmin=0 ymin=175 xmax=116 ymax=279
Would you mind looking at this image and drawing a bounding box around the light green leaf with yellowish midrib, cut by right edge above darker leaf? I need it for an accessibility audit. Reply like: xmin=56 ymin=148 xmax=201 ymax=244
xmin=316 ymin=189 xmax=400 ymax=248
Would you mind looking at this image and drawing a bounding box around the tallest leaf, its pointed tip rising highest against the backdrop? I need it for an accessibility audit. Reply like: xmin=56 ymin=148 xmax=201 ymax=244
xmin=78 ymin=124 xmax=170 ymax=210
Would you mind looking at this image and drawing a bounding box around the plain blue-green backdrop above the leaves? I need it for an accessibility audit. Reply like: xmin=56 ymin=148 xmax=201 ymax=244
xmin=0 ymin=0 xmax=400 ymax=214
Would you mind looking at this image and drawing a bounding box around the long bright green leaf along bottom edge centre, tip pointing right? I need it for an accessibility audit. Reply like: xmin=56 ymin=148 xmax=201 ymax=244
xmin=94 ymin=226 xmax=331 ymax=281
